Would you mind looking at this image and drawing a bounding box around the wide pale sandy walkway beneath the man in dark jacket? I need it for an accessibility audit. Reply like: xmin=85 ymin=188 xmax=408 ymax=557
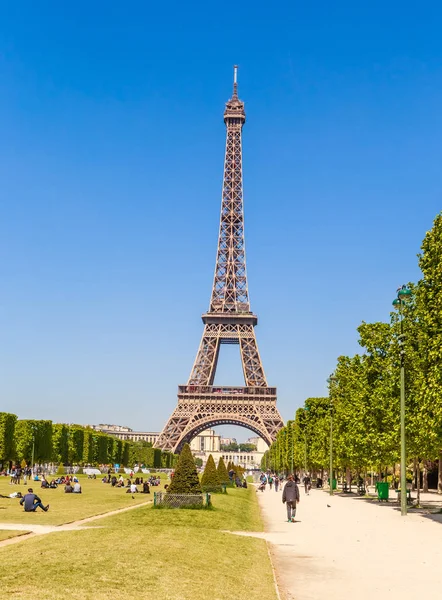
xmin=254 ymin=488 xmax=442 ymax=600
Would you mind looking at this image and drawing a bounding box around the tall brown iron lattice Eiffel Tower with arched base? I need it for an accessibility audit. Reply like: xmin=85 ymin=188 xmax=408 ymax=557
xmin=155 ymin=66 xmax=283 ymax=452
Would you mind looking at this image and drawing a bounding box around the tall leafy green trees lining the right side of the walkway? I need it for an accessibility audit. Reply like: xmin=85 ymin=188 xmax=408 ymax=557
xmin=262 ymin=214 xmax=442 ymax=493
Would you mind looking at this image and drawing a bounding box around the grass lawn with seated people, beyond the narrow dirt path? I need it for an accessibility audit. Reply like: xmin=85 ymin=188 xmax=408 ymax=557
xmin=0 ymin=476 xmax=167 ymax=525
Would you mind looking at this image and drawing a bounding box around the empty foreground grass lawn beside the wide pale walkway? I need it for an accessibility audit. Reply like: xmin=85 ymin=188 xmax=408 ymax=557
xmin=0 ymin=489 xmax=276 ymax=600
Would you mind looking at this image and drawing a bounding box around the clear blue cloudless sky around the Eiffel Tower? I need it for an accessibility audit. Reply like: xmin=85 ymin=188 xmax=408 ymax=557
xmin=0 ymin=1 xmax=442 ymax=435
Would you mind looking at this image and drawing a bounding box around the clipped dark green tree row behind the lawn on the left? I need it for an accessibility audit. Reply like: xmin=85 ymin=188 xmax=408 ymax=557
xmin=0 ymin=413 xmax=175 ymax=468
